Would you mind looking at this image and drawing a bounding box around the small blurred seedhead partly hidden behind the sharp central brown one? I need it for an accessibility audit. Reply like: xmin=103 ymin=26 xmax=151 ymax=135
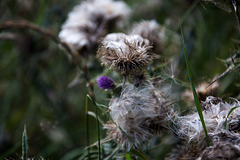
xmin=131 ymin=20 xmax=162 ymax=53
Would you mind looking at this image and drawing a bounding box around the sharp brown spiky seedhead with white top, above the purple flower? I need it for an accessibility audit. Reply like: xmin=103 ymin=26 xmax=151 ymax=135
xmin=98 ymin=33 xmax=153 ymax=74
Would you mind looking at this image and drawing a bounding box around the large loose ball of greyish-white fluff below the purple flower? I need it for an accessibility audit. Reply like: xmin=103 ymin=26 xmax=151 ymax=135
xmin=105 ymin=84 xmax=173 ymax=150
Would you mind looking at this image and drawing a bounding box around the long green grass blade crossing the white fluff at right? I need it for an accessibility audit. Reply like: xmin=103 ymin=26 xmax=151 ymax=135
xmin=181 ymin=28 xmax=210 ymax=146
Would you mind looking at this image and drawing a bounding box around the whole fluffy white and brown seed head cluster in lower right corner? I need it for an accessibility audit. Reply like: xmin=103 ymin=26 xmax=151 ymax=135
xmin=170 ymin=96 xmax=240 ymax=160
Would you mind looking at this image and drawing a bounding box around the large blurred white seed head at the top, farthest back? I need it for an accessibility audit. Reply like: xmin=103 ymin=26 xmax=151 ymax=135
xmin=59 ymin=0 xmax=130 ymax=50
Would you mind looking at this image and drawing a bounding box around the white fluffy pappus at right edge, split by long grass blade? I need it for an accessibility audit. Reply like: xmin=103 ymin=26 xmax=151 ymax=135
xmin=177 ymin=96 xmax=240 ymax=142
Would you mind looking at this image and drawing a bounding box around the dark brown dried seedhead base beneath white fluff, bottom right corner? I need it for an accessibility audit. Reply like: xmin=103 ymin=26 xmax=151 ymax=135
xmin=167 ymin=131 xmax=240 ymax=160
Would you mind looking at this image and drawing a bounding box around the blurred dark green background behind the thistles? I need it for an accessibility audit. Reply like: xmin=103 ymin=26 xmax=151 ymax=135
xmin=0 ymin=0 xmax=240 ymax=159
